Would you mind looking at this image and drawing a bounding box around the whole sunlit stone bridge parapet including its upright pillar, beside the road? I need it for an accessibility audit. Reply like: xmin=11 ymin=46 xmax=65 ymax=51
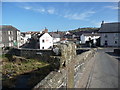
xmin=33 ymin=43 xmax=96 ymax=89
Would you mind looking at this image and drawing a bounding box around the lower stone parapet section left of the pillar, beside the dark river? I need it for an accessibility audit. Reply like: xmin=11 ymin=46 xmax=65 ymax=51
xmin=34 ymin=69 xmax=67 ymax=89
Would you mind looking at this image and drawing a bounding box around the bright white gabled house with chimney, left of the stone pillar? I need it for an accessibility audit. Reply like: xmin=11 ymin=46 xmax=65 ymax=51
xmin=39 ymin=29 xmax=53 ymax=49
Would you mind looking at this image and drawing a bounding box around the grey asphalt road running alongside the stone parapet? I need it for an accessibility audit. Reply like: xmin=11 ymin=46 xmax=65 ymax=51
xmin=87 ymin=48 xmax=120 ymax=88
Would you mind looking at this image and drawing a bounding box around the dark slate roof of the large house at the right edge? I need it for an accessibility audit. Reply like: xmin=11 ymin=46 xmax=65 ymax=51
xmin=99 ymin=22 xmax=120 ymax=33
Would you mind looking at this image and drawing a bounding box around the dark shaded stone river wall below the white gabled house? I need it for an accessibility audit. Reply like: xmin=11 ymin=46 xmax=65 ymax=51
xmin=7 ymin=48 xmax=54 ymax=61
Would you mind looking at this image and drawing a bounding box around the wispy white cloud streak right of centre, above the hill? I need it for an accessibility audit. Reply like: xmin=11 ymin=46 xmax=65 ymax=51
xmin=64 ymin=11 xmax=95 ymax=20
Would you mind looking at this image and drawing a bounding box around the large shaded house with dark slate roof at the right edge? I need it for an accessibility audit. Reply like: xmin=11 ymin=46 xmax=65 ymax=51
xmin=99 ymin=22 xmax=120 ymax=46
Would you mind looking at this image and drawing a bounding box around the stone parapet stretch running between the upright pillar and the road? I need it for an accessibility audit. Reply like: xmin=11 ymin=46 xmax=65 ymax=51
xmin=74 ymin=49 xmax=96 ymax=87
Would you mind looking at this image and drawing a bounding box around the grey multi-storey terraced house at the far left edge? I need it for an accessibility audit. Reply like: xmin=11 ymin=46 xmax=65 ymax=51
xmin=0 ymin=25 xmax=21 ymax=48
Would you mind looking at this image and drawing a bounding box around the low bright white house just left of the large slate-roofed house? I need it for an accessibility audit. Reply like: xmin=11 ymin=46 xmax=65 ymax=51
xmin=80 ymin=33 xmax=100 ymax=44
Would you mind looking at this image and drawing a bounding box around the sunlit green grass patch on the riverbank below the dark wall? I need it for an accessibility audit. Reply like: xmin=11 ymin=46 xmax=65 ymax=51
xmin=3 ymin=59 xmax=49 ymax=76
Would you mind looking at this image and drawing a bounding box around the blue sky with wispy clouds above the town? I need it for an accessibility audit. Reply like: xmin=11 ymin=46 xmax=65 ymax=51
xmin=2 ymin=2 xmax=118 ymax=32
